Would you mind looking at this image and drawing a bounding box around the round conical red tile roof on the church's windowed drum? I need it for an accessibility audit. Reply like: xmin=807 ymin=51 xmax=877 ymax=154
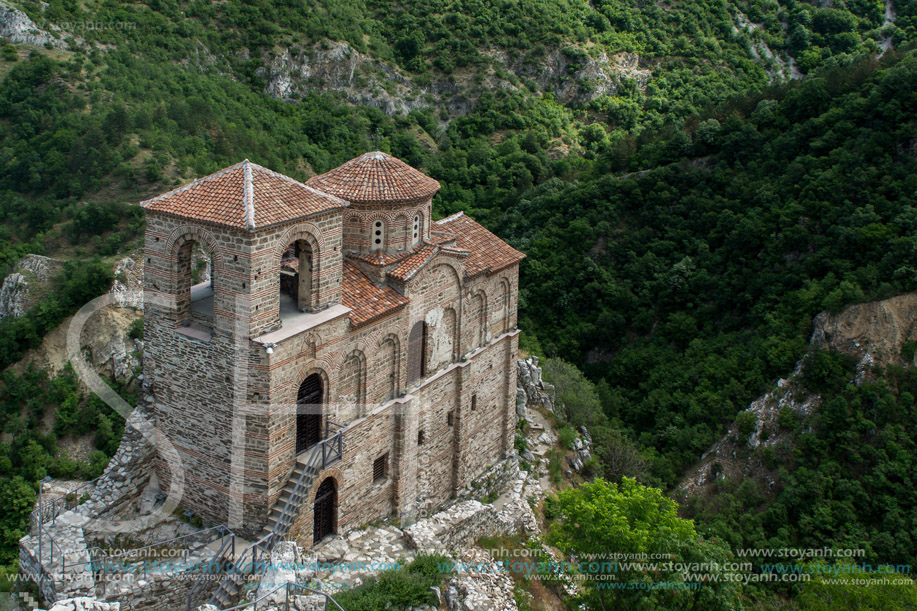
xmin=306 ymin=151 xmax=439 ymax=204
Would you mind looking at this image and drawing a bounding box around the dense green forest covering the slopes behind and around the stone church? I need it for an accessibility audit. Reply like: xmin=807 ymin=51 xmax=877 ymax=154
xmin=0 ymin=0 xmax=917 ymax=608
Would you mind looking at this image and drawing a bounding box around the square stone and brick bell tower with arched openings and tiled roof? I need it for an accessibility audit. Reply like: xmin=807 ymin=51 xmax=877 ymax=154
xmin=141 ymin=160 xmax=346 ymax=532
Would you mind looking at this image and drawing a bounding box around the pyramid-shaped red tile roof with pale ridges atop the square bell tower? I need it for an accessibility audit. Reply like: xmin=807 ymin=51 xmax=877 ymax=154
xmin=140 ymin=159 xmax=347 ymax=231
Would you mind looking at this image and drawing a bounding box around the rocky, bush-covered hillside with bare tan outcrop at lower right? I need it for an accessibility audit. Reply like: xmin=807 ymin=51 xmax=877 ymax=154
xmin=677 ymin=293 xmax=917 ymax=564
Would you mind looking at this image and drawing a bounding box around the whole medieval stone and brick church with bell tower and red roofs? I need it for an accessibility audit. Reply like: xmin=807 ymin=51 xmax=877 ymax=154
xmin=142 ymin=152 xmax=523 ymax=547
